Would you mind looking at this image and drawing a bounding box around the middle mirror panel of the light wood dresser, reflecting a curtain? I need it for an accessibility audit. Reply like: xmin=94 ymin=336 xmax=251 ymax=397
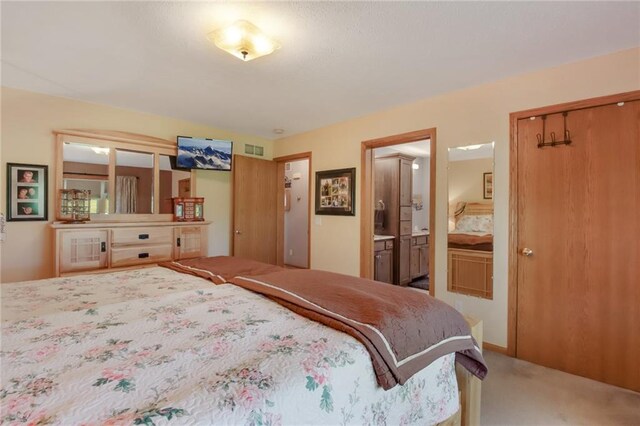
xmin=115 ymin=149 xmax=153 ymax=214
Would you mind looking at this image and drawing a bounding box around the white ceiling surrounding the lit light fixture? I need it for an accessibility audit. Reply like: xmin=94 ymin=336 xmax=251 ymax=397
xmin=2 ymin=1 xmax=640 ymax=138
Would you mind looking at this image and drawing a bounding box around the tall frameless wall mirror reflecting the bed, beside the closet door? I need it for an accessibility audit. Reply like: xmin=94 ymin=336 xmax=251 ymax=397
xmin=447 ymin=142 xmax=494 ymax=299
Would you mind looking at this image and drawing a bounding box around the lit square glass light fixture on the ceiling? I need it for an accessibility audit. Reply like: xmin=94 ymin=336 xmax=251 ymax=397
xmin=207 ymin=20 xmax=280 ymax=62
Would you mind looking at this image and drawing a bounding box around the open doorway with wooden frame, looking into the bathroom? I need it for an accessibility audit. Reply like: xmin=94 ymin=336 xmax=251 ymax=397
xmin=360 ymin=129 xmax=435 ymax=295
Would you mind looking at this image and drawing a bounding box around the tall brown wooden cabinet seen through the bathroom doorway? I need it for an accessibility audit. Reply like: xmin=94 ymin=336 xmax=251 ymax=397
xmin=374 ymin=154 xmax=415 ymax=285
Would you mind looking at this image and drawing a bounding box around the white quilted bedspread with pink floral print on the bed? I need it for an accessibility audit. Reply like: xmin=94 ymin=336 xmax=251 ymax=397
xmin=0 ymin=255 xmax=486 ymax=425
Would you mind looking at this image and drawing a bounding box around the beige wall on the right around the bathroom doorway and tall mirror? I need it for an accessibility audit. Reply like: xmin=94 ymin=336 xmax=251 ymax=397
xmin=274 ymin=48 xmax=640 ymax=346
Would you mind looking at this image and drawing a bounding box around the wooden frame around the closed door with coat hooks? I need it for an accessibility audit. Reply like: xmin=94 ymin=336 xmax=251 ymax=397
xmin=506 ymin=90 xmax=640 ymax=357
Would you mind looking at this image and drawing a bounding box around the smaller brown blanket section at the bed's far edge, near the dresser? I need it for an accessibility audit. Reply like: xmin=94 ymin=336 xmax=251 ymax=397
xmin=158 ymin=256 xmax=284 ymax=284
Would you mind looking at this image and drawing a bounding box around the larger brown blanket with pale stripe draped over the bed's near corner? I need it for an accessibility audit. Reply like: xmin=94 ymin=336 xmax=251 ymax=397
xmin=230 ymin=270 xmax=487 ymax=389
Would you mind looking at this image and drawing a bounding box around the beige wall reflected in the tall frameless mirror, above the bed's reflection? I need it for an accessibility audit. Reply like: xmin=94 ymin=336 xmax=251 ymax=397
xmin=448 ymin=158 xmax=493 ymax=205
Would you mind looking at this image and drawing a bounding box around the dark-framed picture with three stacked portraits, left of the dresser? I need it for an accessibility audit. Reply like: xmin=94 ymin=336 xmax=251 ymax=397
xmin=7 ymin=163 xmax=49 ymax=221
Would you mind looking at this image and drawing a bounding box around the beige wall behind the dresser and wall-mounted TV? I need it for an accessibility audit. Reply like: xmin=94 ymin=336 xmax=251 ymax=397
xmin=0 ymin=87 xmax=273 ymax=282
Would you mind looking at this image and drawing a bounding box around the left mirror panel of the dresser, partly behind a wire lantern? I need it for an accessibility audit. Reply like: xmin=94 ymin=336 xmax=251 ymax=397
xmin=62 ymin=143 xmax=109 ymax=214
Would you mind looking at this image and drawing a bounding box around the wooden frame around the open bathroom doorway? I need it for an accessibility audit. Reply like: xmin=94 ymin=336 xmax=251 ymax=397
xmin=360 ymin=127 xmax=436 ymax=296
